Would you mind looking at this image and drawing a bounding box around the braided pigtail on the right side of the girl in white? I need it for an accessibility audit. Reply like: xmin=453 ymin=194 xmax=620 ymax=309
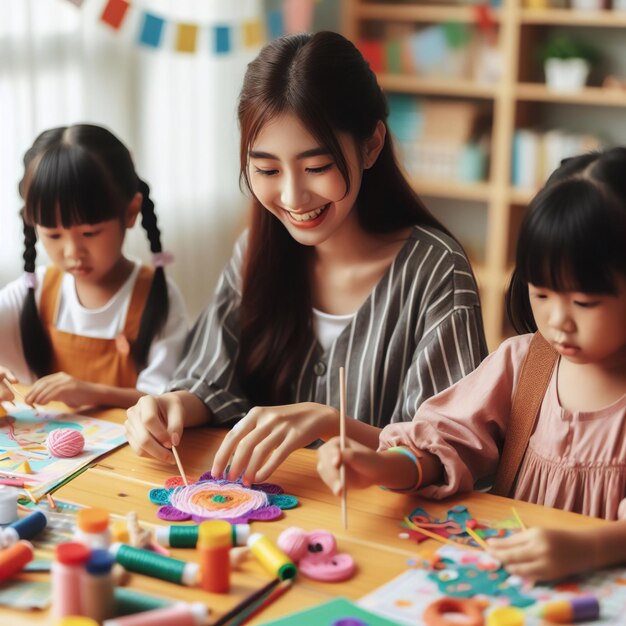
xmin=132 ymin=178 xmax=169 ymax=370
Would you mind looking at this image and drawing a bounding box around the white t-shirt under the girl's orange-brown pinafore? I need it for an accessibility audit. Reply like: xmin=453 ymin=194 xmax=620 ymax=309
xmin=0 ymin=262 xmax=189 ymax=394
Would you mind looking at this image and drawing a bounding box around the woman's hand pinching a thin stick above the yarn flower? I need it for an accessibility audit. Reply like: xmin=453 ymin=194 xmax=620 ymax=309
xmin=124 ymin=391 xmax=208 ymax=463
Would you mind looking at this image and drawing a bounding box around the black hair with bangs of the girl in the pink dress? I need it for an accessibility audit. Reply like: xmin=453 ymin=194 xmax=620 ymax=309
xmin=517 ymin=180 xmax=623 ymax=293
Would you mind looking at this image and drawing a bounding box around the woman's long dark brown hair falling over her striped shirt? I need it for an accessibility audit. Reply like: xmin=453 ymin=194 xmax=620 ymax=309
xmin=238 ymin=32 xmax=450 ymax=405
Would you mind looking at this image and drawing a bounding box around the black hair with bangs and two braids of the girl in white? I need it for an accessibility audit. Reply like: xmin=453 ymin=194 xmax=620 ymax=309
xmin=19 ymin=124 xmax=169 ymax=377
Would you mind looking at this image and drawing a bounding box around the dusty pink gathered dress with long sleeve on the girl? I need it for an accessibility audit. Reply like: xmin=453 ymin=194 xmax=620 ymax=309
xmin=379 ymin=335 xmax=626 ymax=520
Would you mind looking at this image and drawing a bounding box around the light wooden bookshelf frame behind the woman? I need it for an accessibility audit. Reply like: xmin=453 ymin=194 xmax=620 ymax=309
xmin=342 ymin=0 xmax=626 ymax=350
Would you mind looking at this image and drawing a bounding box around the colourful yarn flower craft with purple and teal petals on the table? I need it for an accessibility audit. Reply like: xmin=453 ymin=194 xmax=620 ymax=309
xmin=149 ymin=472 xmax=298 ymax=524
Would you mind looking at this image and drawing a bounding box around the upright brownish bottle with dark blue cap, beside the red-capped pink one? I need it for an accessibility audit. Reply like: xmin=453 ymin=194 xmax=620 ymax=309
xmin=80 ymin=550 xmax=115 ymax=623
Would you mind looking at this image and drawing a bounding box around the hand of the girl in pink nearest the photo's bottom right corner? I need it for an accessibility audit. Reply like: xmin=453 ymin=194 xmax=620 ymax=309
xmin=487 ymin=528 xmax=595 ymax=581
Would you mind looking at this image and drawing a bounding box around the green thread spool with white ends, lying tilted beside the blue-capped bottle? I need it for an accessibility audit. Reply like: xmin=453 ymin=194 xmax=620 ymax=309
xmin=109 ymin=543 xmax=200 ymax=587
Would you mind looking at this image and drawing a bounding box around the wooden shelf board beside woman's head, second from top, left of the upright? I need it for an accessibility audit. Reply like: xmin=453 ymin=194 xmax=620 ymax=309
xmin=378 ymin=74 xmax=496 ymax=100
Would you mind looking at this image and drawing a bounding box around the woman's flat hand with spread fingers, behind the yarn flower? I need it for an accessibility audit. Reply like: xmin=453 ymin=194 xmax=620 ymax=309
xmin=211 ymin=402 xmax=339 ymax=485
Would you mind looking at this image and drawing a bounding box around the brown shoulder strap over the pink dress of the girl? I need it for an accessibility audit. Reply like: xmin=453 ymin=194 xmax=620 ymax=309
xmin=491 ymin=333 xmax=558 ymax=496
